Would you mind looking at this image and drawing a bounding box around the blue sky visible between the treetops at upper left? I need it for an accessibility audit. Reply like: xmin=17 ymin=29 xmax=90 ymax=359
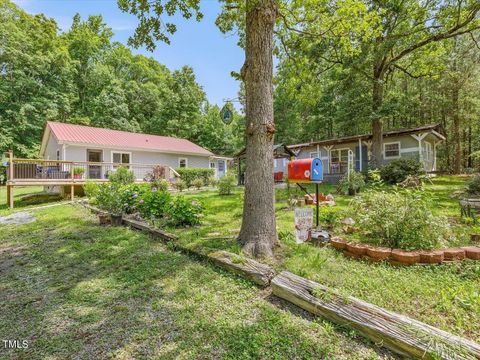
xmin=14 ymin=0 xmax=245 ymax=109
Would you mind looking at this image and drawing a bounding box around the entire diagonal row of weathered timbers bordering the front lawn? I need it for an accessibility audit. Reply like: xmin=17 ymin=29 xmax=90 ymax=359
xmin=75 ymin=203 xmax=480 ymax=359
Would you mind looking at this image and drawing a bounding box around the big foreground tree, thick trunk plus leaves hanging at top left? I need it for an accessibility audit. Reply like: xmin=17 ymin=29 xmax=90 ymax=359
xmin=118 ymin=0 xmax=278 ymax=257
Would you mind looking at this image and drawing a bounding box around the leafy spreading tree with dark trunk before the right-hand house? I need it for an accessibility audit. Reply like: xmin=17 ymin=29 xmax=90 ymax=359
xmin=281 ymin=0 xmax=480 ymax=164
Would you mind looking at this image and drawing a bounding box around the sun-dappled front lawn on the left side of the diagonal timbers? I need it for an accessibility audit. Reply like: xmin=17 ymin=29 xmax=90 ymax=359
xmin=0 ymin=204 xmax=398 ymax=359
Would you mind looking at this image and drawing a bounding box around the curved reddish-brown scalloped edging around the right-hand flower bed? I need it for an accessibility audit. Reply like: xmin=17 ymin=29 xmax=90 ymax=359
xmin=330 ymin=236 xmax=480 ymax=265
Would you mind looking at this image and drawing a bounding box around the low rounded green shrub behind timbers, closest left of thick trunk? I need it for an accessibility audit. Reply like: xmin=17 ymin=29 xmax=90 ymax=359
xmin=165 ymin=196 xmax=203 ymax=226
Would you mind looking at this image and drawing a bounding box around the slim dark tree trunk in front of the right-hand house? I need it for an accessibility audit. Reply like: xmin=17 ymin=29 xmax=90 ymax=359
xmin=371 ymin=74 xmax=384 ymax=168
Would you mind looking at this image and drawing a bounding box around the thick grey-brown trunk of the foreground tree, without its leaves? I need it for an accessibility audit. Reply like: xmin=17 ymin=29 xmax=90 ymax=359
xmin=238 ymin=0 xmax=277 ymax=257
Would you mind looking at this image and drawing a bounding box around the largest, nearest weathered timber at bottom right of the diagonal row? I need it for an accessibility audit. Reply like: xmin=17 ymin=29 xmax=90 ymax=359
xmin=271 ymin=271 xmax=480 ymax=359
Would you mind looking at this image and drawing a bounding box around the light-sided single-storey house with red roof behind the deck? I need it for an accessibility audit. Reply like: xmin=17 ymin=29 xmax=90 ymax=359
xmin=40 ymin=122 xmax=229 ymax=180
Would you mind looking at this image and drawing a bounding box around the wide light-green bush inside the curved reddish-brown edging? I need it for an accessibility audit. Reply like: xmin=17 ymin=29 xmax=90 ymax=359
xmin=349 ymin=190 xmax=454 ymax=250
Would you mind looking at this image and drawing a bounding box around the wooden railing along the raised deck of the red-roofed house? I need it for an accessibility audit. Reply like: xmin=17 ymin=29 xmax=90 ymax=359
xmin=7 ymin=159 xmax=179 ymax=183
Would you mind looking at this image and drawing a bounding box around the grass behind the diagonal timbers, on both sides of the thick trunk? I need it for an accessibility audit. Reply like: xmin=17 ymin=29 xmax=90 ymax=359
xmin=170 ymin=176 xmax=480 ymax=341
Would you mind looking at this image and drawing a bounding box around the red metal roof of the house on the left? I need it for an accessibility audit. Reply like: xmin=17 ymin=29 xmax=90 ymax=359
xmin=47 ymin=121 xmax=213 ymax=156
